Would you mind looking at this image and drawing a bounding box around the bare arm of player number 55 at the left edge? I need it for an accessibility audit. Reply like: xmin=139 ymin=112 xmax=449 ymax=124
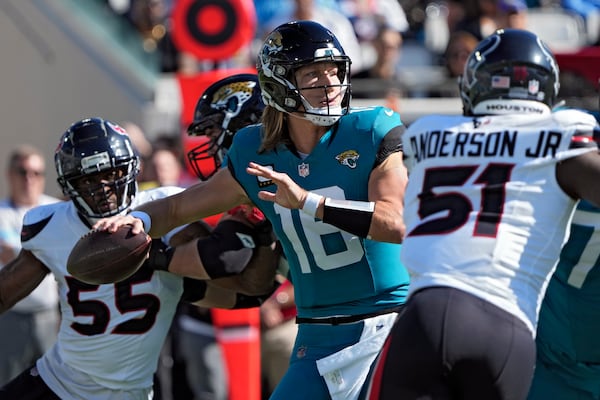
xmin=0 ymin=250 xmax=50 ymax=313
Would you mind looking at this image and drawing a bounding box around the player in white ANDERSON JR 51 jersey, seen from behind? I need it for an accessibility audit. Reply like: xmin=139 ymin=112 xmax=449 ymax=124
xmin=369 ymin=29 xmax=600 ymax=400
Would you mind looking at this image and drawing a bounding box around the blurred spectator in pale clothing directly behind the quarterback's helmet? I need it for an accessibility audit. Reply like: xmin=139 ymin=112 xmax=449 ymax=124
xmin=257 ymin=0 xmax=364 ymax=73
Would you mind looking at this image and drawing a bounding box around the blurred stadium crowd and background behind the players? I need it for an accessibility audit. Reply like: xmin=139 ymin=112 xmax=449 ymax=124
xmin=0 ymin=0 xmax=600 ymax=400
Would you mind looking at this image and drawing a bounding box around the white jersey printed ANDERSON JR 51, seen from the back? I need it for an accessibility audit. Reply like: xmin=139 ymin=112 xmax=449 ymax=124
xmin=401 ymin=110 xmax=597 ymax=335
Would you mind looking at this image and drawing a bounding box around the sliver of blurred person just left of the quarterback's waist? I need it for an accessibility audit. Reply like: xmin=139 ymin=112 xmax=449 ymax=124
xmin=260 ymin=278 xmax=298 ymax=399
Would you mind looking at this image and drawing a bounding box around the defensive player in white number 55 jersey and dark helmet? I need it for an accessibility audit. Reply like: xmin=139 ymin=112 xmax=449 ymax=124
xmin=0 ymin=118 xmax=275 ymax=400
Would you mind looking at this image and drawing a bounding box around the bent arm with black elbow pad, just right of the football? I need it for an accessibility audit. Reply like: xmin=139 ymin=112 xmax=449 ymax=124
xmin=146 ymin=207 xmax=281 ymax=295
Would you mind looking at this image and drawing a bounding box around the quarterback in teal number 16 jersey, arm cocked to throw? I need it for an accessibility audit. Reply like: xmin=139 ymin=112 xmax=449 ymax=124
xmin=94 ymin=21 xmax=409 ymax=400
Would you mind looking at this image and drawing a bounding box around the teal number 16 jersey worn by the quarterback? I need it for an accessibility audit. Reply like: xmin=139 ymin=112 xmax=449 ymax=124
xmin=226 ymin=107 xmax=409 ymax=318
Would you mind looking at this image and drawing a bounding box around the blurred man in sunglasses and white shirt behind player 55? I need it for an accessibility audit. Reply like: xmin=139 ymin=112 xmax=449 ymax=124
xmin=0 ymin=145 xmax=60 ymax=386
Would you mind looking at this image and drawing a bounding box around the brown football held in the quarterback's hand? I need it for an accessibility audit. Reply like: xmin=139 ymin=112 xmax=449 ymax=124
xmin=67 ymin=225 xmax=152 ymax=285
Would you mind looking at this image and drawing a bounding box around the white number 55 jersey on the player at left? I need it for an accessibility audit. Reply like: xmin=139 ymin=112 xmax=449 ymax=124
xmin=21 ymin=187 xmax=184 ymax=399
